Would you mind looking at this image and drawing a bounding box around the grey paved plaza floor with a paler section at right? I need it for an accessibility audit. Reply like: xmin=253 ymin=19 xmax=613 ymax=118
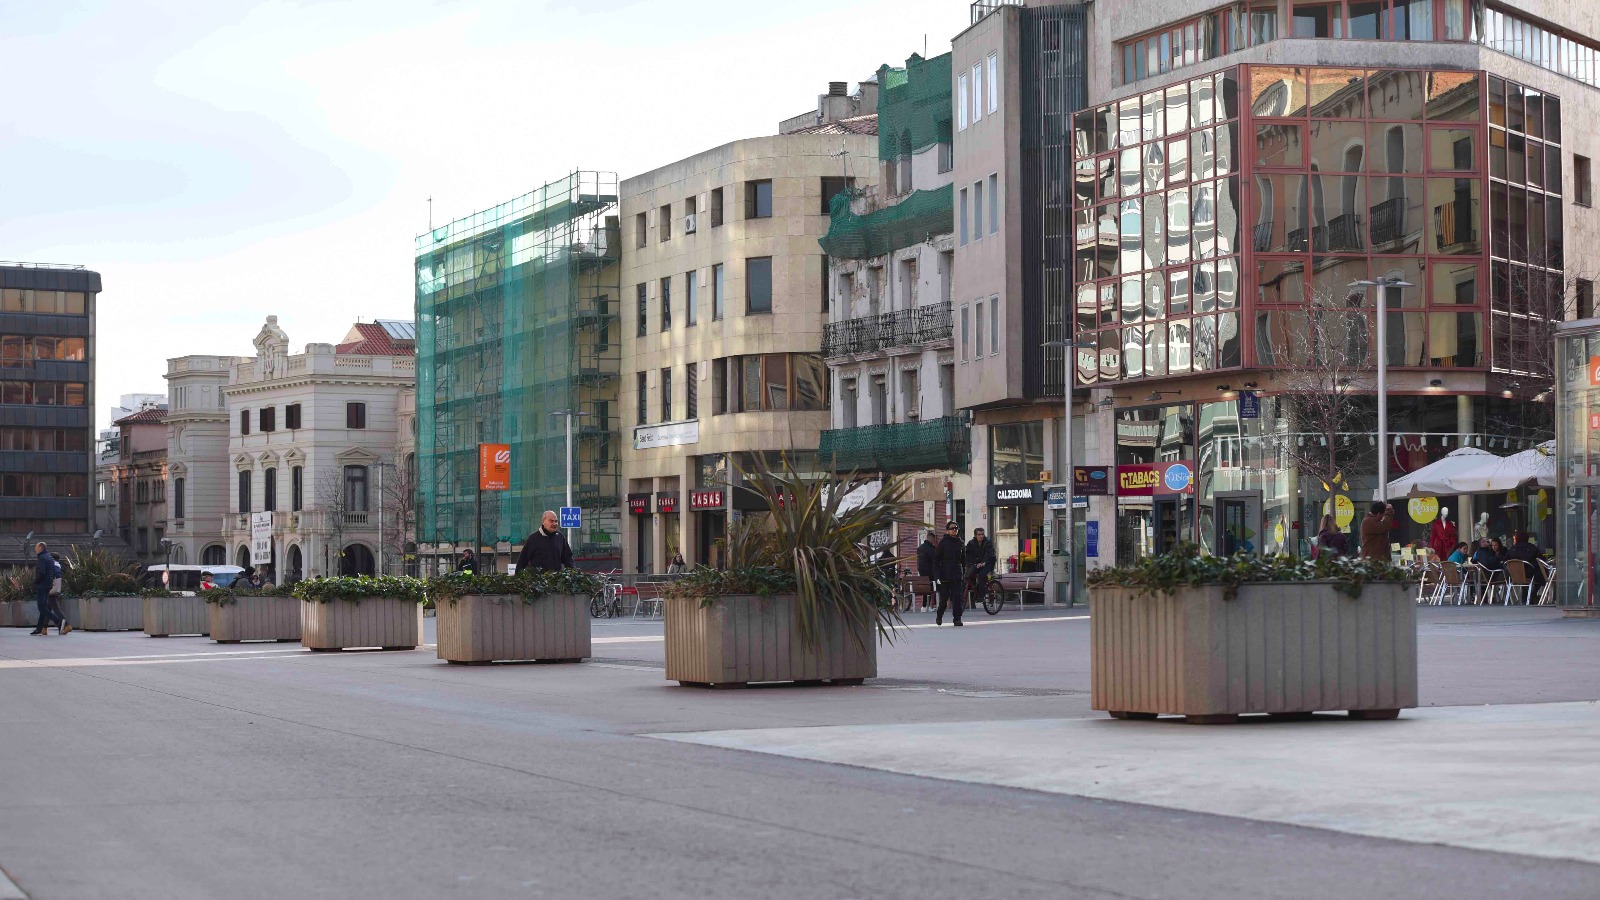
xmin=0 ymin=607 xmax=1600 ymax=900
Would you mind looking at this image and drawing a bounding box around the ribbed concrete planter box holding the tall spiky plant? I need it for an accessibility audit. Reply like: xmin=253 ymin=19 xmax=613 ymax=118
xmin=664 ymin=594 xmax=878 ymax=687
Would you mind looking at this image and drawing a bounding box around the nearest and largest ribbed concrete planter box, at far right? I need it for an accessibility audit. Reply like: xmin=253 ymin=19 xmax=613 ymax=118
xmin=1090 ymin=581 xmax=1418 ymax=724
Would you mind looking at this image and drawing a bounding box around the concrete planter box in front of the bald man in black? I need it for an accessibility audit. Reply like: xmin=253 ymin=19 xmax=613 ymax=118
xmin=438 ymin=594 xmax=590 ymax=663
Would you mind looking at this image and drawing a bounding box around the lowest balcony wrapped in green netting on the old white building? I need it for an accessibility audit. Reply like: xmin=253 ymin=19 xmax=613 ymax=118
xmin=818 ymin=416 xmax=971 ymax=474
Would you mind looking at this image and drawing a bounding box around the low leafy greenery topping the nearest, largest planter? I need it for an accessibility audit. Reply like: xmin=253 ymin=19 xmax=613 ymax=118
xmin=1088 ymin=544 xmax=1416 ymax=601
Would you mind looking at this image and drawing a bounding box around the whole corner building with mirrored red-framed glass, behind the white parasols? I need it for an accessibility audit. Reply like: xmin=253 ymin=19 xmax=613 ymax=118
xmin=1049 ymin=0 xmax=1600 ymax=573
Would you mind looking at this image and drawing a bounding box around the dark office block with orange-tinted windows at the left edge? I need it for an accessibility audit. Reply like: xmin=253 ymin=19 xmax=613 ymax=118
xmin=0 ymin=263 xmax=101 ymax=562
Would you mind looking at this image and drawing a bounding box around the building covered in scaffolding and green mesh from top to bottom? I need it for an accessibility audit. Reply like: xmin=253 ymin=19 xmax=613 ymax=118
xmin=416 ymin=171 xmax=621 ymax=569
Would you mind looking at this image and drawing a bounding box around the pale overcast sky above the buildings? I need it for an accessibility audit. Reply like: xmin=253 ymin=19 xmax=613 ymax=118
xmin=0 ymin=0 xmax=968 ymax=426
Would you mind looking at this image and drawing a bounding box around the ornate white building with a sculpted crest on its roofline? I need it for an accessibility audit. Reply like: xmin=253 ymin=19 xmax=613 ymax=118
xmin=206 ymin=315 xmax=416 ymax=581
